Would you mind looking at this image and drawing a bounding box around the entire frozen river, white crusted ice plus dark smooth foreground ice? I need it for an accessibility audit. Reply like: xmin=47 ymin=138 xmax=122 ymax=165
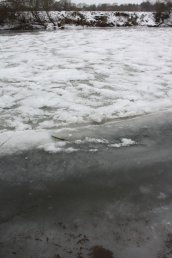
xmin=0 ymin=28 xmax=172 ymax=258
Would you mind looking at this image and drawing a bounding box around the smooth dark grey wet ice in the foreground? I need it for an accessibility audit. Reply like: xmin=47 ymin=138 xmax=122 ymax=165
xmin=0 ymin=125 xmax=172 ymax=258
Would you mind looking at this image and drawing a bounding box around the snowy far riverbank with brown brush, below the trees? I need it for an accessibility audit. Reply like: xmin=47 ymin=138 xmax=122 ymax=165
xmin=0 ymin=11 xmax=172 ymax=30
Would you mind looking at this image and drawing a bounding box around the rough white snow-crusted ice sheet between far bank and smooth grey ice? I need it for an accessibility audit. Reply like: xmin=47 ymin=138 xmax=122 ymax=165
xmin=0 ymin=28 xmax=172 ymax=132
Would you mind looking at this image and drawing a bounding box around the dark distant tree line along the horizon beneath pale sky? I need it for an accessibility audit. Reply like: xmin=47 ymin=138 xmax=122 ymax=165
xmin=0 ymin=0 xmax=172 ymax=12
